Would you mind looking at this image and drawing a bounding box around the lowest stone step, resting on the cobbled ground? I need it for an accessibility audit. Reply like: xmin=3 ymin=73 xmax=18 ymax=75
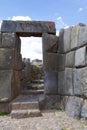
xmin=11 ymin=109 xmax=42 ymax=119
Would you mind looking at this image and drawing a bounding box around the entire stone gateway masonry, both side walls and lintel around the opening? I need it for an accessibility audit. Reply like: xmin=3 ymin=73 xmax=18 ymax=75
xmin=0 ymin=21 xmax=87 ymax=118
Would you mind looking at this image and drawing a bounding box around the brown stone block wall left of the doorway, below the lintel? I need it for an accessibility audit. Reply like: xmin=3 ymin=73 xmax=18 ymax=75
xmin=0 ymin=32 xmax=22 ymax=102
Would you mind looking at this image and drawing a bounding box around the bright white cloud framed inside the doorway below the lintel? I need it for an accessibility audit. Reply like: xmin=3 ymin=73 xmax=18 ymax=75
xmin=21 ymin=37 xmax=42 ymax=60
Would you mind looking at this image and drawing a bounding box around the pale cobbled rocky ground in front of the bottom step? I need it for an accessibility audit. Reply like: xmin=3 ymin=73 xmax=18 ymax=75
xmin=0 ymin=110 xmax=87 ymax=130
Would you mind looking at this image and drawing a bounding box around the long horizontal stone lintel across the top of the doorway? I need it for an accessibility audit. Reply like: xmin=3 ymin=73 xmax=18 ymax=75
xmin=1 ymin=20 xmax=56 ymax=36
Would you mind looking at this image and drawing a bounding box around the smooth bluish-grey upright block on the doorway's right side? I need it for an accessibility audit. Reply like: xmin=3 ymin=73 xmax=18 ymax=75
xmin=44 ymin=71 xmax=58 ymax=94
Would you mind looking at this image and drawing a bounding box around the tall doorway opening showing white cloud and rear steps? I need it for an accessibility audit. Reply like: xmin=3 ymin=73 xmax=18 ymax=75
xmin=20 ymin=37 xmax=44 ymax=91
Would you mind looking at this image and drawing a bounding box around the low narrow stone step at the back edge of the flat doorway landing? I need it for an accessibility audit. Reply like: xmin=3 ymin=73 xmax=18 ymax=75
xmin=21 ymin=89 xmax=44 ymax=95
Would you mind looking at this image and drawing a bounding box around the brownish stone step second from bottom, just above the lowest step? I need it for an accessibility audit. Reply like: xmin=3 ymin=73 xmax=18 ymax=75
xmin=12 ymin=101 xmax=39 ymax=110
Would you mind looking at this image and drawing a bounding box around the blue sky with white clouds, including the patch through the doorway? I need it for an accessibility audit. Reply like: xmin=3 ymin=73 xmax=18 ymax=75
xmin=0 ymin=0 xmax=87 ymax=59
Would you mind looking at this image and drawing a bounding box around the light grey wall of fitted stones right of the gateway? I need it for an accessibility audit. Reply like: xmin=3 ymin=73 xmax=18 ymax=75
xmin=58 ymin=24 xmax=87 ymax=118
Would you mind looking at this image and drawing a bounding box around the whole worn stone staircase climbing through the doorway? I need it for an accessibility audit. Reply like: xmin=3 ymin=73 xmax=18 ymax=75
xmin=11 ymin=80 xmax=45 ymax=119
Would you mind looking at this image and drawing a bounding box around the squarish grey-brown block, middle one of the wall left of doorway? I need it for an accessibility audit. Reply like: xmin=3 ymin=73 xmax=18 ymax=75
xmin=0 ymin=48 xmax=14 ymax=70
